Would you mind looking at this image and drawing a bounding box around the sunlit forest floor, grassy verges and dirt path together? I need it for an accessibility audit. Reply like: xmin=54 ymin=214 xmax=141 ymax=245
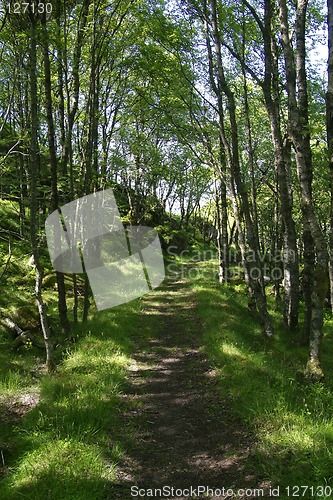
xmin=0 ymin=260 xmax=333 ymax=500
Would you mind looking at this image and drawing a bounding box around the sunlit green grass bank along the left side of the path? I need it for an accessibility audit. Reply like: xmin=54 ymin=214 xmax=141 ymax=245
xmin=0 ymin=300 xmax=147 ymax=500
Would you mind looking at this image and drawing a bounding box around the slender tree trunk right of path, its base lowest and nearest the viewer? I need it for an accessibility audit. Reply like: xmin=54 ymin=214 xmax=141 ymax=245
xmin=279 ymin=0 xmax=329 ymax=380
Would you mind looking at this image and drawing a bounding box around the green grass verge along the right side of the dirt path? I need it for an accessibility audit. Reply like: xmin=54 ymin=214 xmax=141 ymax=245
xmin=193 ymin=262 xmax=333 ymax=492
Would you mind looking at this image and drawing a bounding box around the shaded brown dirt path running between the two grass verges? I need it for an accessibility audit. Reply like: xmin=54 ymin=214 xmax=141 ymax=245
xmin=107 ymin=278 xmax=258 ymax=500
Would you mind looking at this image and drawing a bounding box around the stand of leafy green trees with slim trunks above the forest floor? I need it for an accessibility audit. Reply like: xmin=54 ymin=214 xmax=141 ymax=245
xmin=0 ymin=0 xmax=333 ymax=376
